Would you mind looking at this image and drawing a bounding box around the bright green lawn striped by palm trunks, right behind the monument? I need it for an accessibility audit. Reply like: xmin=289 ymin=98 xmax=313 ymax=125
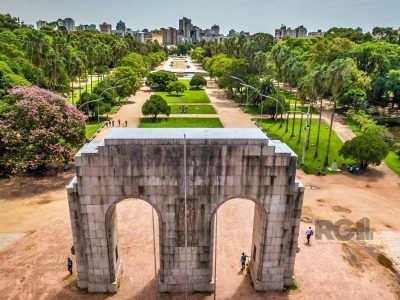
xmin=257 ymin=119 xmax=353 ymax=174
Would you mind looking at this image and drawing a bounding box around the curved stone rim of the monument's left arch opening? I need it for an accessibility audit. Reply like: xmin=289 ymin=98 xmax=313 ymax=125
xmin=105 ymin=197 xmax=163 ymax=282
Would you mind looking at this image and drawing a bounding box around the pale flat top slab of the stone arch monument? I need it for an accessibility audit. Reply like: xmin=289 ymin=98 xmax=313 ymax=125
xmin=105 ymin=128 xmax=268 ymax=140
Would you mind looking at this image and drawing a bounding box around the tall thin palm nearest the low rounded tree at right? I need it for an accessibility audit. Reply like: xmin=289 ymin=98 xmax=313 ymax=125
xmin=324 ymin=59 xmax=351 ymax=166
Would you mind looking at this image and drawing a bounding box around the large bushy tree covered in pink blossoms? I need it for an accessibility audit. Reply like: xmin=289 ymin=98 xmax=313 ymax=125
xmin=0 ymin=86 xmax=85 ymax=171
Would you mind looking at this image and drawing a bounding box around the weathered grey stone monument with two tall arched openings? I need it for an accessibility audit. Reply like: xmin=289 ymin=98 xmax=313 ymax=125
xmin=67 ymin=129 xmax=304 ymax=292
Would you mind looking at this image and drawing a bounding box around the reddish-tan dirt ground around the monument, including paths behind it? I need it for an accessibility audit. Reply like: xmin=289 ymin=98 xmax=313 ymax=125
xmin=0 ymin=62 xmax=400 ymax=300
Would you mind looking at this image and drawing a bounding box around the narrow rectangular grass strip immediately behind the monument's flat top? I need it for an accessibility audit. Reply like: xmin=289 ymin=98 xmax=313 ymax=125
xmin=139 ymin=118 xmax=223 ymax=128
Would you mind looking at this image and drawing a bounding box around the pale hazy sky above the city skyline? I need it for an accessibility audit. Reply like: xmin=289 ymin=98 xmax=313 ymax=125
xmin=0 ymin=0 xmax=400 ymax=33
